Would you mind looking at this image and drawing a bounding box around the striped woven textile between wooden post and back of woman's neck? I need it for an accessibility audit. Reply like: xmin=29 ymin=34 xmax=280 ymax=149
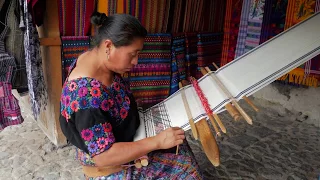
xmin=61 ymin=36 xmax=90 ymax=82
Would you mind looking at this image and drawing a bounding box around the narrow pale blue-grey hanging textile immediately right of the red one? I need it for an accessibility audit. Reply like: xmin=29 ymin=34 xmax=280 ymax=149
xmin=235 ymin=0 xmax=251 ymax=58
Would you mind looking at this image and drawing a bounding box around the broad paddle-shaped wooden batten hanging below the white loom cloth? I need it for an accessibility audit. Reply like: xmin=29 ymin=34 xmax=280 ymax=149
xmin=181 ymin=80 xmax=220 ymax=167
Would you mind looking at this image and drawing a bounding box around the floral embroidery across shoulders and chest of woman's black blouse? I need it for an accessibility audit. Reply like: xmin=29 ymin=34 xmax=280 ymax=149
xmin=61 ymin=76 xmax=130 ymax=122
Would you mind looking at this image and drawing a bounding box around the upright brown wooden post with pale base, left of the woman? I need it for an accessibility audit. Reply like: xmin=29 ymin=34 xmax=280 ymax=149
xmin=37 ymin=1 xmax=67 ymax=146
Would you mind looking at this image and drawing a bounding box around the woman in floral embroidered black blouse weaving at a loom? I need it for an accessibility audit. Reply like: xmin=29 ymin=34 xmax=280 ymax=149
xmin=60 ymin=13 xmax=201 ymax=179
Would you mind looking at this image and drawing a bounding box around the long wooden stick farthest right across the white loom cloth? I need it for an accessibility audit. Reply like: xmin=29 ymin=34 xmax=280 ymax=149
xmin=205 ymin=67 xmax=252 ymax=124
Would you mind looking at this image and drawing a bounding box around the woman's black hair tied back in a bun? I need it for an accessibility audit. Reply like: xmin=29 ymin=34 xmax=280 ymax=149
xmin=91 ymin=12 xmax=147 ymax=47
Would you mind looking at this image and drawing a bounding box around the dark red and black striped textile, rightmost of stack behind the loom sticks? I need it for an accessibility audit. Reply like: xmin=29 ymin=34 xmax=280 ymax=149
xmin=196 ymin=33 xmax=223 ymax=78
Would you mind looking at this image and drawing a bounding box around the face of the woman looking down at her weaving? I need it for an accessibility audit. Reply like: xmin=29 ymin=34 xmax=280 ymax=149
xmin=107 ymin=38 xmax=144 ymax=74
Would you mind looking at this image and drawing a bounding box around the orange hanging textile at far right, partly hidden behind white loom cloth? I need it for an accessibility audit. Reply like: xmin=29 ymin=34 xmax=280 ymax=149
xmin=279 ymin=0 xmax=320 ymax=87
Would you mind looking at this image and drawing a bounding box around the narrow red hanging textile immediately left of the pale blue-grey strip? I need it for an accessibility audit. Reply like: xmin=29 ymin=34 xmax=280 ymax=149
xmin=221 ymin=0 xmax=243 ymax=66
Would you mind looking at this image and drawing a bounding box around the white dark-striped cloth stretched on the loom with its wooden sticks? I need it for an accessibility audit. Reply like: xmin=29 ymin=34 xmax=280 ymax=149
xmin=132 ymin=12 xmax=320 ymax=166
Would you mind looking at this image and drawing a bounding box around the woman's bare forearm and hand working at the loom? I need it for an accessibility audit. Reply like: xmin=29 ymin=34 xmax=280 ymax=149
xmin=93 ymin=128 xmax=185 ymax=167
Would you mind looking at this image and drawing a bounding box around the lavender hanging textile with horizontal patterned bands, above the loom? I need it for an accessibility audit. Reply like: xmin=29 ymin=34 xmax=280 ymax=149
xmin=244 ymin=0 xmax=265 ymax=53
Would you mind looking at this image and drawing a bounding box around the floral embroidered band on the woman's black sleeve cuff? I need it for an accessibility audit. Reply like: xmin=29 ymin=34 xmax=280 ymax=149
xmin=81 ymin=123 xmax=115 ymax=156
